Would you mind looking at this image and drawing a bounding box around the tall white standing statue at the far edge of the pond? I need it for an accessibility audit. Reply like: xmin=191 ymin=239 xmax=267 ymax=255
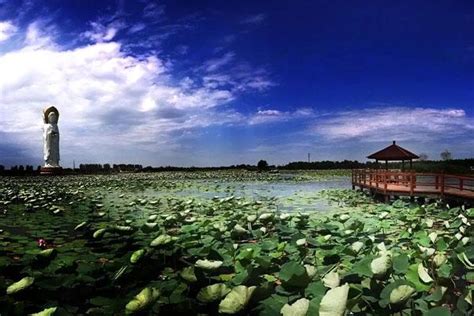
xmin=43 ymin=106 xmax=60 ymax=169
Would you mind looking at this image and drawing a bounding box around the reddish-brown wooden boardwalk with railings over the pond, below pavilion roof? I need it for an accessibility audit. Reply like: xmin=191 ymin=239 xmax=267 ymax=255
xmin=352 ymin=169 xmax=474 ymax=201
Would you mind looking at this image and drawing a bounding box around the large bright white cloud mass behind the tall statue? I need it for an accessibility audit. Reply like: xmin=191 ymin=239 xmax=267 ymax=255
xmin=0 ymin=24 xmax=252 ymax=163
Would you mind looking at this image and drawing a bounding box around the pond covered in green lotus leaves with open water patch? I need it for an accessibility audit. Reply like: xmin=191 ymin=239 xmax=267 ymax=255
xmin=0 ymin=171 xmax=474 ymax=316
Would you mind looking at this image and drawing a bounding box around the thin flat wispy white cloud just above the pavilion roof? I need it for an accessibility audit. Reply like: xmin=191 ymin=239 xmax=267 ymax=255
xmin=314 ymin=107 xmax=474 ymax=141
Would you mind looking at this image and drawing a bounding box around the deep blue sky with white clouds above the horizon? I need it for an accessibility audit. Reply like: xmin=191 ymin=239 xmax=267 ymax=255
xmin=0 ymin=0 xmax=474 ymax=167
